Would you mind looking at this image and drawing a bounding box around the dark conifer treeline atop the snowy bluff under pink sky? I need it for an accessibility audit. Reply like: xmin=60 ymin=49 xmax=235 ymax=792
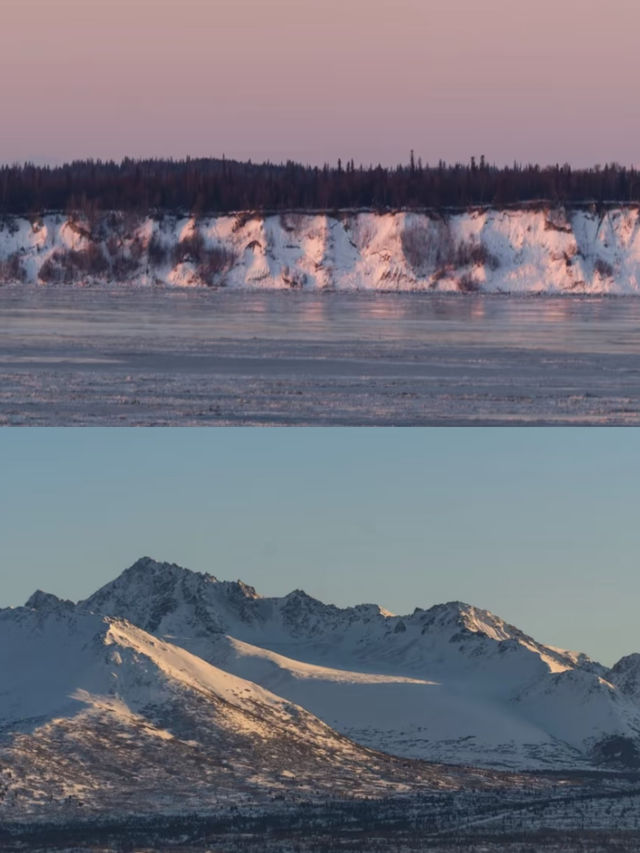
xmin=0 ymin=153 xmax=640 ymax=214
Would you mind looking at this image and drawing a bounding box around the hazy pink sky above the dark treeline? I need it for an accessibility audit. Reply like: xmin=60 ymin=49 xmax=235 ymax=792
xmin=5 ymin=0 xmax=640 ymax=165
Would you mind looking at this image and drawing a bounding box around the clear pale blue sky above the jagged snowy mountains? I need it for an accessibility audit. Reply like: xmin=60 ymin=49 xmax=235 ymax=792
xmin=0 ymin=428 xmax=640 ymax=663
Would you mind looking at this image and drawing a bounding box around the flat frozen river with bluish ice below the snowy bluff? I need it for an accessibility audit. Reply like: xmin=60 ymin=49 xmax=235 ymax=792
xmin=0 ymin=287 xmax=640 ymax=426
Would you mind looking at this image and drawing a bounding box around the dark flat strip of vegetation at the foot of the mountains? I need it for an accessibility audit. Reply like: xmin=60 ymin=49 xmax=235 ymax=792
xmin=0 ymin=774 xmax=640 ymax=853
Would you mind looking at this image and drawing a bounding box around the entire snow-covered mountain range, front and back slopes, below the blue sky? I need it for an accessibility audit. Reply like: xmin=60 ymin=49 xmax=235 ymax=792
xmin=6 ymin=557 xmax=640 ymax=836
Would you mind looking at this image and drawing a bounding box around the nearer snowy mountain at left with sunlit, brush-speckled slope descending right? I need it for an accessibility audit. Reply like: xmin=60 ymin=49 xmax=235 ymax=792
xmin=0 ymin=596 xmax=505 ymax=821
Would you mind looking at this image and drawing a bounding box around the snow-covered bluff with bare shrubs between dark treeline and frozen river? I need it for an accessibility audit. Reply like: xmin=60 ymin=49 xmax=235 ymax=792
xmin=0 ymin=205 xmax=640 ymax=294
